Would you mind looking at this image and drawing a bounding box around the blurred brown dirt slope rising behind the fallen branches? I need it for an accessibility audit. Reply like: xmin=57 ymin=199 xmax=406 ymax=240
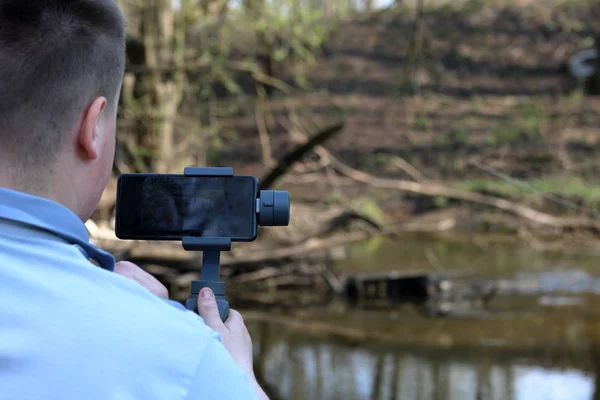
xmin=222 ymin=2 xmax=600 ymax=188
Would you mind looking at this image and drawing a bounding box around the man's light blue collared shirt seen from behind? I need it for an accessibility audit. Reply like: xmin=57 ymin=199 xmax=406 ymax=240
xmin=0 ymin=188 xmax=256 ymax=400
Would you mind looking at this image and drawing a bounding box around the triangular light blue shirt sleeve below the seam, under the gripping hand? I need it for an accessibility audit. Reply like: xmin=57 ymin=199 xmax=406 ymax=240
xmin=186 ymin=337 xmax=258 ymax=400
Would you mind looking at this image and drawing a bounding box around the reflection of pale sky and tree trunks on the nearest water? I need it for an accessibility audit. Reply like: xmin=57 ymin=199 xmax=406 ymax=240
xmin=251 ymin=316 xmax=597 ymax=400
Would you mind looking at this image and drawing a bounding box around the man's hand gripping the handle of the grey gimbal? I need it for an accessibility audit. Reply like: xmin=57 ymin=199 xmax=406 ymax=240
xmin=198 ymin=288 xmax=269 ymax=400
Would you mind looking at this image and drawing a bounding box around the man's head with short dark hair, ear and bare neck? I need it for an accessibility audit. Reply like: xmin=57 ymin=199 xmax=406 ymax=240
xmin=0 ymin=0 xmax=125 ymax=220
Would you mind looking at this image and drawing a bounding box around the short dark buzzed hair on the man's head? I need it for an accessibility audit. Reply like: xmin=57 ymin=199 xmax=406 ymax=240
xmin=0 ymin=0 xmax=125 ymax=173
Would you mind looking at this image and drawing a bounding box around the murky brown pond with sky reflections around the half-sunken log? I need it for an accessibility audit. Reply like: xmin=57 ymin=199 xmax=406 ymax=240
xmin=244 ymin=235 xmax=600 ymax=400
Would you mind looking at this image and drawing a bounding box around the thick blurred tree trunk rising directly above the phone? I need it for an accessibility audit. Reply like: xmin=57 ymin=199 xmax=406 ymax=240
xmin=123 ymin=0 xmax=190 ymax=173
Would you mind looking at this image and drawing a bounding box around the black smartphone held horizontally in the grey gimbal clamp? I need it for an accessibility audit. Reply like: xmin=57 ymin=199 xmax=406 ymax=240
xmin=115 ymin=174 xmax=258 ymax=242
